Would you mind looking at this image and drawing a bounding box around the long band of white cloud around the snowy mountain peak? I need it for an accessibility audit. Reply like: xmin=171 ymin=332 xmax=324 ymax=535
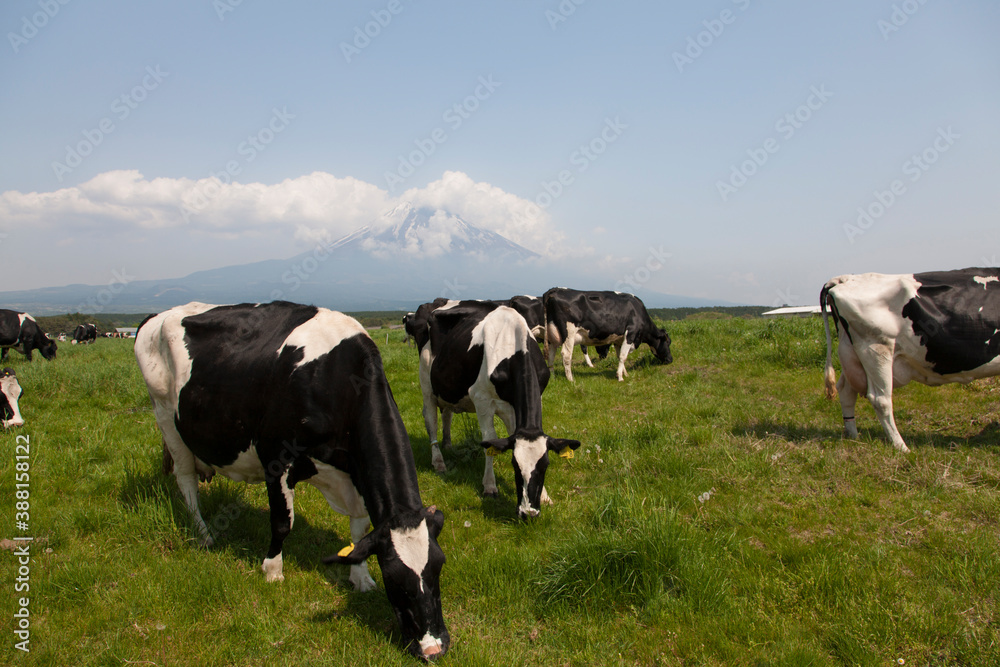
xmin=0 ymin=170 xmax=572 ymax=256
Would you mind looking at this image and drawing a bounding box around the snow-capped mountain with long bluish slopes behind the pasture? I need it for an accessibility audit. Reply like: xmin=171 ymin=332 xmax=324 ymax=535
xmin=0 ymin=204 xmax=737 ymax=315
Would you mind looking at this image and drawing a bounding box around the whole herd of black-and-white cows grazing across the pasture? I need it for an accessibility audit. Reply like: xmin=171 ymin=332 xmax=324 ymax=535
xmin=0 ymin=268 xmax=1000 ymax=660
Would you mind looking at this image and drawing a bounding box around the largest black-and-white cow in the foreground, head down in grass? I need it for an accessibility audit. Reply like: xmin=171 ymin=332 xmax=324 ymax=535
xmin=135 ymin=301 xmax=450 ymax=659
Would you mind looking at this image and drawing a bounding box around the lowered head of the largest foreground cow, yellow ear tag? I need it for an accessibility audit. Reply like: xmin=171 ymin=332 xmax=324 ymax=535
xmin=323 ymin=506 xmax=451 ymax=660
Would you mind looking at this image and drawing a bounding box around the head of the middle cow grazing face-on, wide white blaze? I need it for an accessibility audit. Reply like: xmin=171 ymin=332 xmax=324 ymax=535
xmin=482 ymin=431 xmax=580 ymax=519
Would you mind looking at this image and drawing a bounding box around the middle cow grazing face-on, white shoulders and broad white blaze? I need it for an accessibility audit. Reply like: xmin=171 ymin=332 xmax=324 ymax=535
xmin=420 ymin=301 xmax=580 ymax=518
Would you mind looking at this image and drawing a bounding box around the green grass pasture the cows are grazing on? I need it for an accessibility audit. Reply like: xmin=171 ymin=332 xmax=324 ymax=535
xmin=0 ymin=319 xmax=1000 ymax=666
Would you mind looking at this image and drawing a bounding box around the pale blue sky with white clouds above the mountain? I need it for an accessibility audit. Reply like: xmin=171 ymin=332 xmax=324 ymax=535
xmin=0 ymin=0 xmax=1000 ymax=305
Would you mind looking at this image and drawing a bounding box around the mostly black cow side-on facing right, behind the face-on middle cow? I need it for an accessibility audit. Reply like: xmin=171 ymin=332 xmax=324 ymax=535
xmin=542 ymin=287 xmax=674 ymax=382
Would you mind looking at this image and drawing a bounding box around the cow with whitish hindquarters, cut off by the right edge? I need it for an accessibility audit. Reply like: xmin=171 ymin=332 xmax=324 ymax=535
xmin=820 ymin=268 xmax=1000 ymax=452
